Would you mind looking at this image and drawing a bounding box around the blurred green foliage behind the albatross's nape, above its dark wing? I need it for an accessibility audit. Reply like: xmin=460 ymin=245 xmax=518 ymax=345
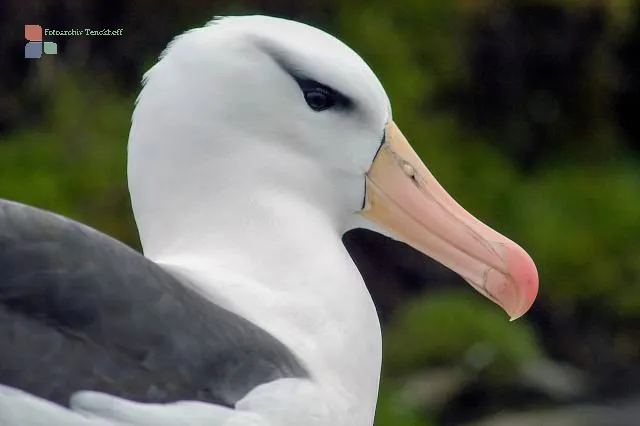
xmin=0 ymin=68 xmax=137 ymax=245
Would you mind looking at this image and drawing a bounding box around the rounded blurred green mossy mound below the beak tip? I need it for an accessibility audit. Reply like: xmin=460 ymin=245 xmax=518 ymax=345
xmin=384 ymin=292 xmax=542 ymax=376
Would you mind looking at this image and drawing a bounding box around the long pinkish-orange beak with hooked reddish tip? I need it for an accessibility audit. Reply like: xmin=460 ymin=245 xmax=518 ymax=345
xmin=361 ymin=122 xmax=538 ymax=320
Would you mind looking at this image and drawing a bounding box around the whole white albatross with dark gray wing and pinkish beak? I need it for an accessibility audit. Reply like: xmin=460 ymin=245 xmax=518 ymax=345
xmin=0 ymin=16 xmax=538 ymax=426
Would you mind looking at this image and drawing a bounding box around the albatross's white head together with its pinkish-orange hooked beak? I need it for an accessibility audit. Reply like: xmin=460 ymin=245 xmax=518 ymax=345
xmin=129 ymin=16 xmax=537 ymax=317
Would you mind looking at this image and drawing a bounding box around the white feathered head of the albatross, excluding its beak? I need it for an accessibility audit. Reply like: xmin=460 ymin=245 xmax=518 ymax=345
xmin=129 ymin=16 xmax=391 ymax=243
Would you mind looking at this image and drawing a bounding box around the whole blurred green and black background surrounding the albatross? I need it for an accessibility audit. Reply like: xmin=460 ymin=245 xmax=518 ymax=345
xmin=0 ymin=0 xmax=640 ymax=426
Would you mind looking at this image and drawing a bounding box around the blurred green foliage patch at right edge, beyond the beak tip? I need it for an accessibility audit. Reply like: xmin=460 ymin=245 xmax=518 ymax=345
xmin=513 ymin=161 xmax=640 ymax=317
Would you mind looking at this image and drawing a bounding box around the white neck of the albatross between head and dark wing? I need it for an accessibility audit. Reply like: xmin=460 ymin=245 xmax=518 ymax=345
xmin=130 ymin=133 xmax=381 ymax=418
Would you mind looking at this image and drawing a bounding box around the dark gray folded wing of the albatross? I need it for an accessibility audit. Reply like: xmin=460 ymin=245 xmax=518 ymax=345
xmin=0 ymin=200 xmax=308 ymax=407
